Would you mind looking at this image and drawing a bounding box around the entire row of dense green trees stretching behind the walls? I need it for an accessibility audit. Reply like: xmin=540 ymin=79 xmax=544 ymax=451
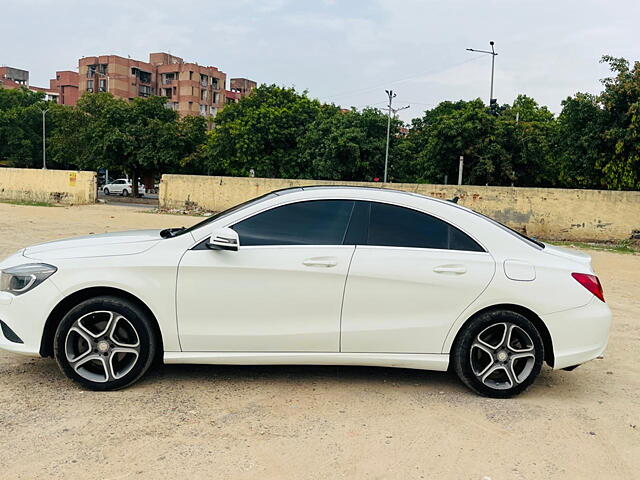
xmin=0 ymin=56 xmax=640 ymax=189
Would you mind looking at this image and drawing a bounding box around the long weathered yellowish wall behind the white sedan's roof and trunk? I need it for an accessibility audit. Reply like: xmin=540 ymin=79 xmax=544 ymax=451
xmin=160 ymin=175 xmax=640 ymax=241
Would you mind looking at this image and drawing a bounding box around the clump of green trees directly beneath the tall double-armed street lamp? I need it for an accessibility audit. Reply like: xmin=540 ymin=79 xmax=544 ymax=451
xmin=407 ymin=95 xmax=556 ymax=186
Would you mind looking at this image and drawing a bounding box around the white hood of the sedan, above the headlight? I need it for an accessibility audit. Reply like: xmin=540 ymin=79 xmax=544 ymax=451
xmin=23 ymin=230 xmax=162 ymax=260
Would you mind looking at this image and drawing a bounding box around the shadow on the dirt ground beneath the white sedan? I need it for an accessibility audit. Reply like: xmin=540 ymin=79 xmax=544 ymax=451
xmin=0 ymin=356 xmax=588 ymax=399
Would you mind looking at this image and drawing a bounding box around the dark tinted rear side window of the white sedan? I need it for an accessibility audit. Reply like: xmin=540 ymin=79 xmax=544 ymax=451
xmin=367 ymin=203 xmax=484 ymax=252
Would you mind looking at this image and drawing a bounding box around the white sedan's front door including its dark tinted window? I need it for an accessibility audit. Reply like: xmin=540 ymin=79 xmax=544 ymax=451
xmin=177 ymin=200 xmax=355 ymax=352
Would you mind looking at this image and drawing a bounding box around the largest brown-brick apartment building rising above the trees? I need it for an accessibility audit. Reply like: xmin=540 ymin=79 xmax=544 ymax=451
xmin=78 ymin=52 xmax=227 ymax=117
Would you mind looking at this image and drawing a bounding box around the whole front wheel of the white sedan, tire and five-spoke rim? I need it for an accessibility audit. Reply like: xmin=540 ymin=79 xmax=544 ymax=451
xmin=54 ymin=297 xmax=157 ymax=390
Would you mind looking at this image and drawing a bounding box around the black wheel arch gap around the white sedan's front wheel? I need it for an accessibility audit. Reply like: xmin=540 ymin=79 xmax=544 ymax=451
xmin=40 ymin=287 xmax=164 ymax=357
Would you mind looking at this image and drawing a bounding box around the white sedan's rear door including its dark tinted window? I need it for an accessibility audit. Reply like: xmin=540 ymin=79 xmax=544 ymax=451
xmin=341 ymin=202 xmax=495 ymax=353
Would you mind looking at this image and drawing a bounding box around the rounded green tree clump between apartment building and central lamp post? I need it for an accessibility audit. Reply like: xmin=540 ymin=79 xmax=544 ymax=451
xmin=205 ymin=85 xmax=400 ymax=180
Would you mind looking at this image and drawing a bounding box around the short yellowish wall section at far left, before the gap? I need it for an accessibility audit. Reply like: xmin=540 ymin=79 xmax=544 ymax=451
xmin=0 ymin=168 xmax=97 ymax=205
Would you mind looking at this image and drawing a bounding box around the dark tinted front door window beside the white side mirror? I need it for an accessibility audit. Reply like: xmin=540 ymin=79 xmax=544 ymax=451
xmin=232 ymin=200 xmax=353 ymax=246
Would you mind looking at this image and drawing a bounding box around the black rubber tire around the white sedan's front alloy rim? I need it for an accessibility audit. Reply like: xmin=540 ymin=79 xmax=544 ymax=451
xmin=54 ymin=296 xmax=158 ymax=391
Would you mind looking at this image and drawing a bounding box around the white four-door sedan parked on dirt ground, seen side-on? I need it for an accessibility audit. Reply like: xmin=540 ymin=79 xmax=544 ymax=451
xmin=0 ymin=187 xmax=611 ymax=397
